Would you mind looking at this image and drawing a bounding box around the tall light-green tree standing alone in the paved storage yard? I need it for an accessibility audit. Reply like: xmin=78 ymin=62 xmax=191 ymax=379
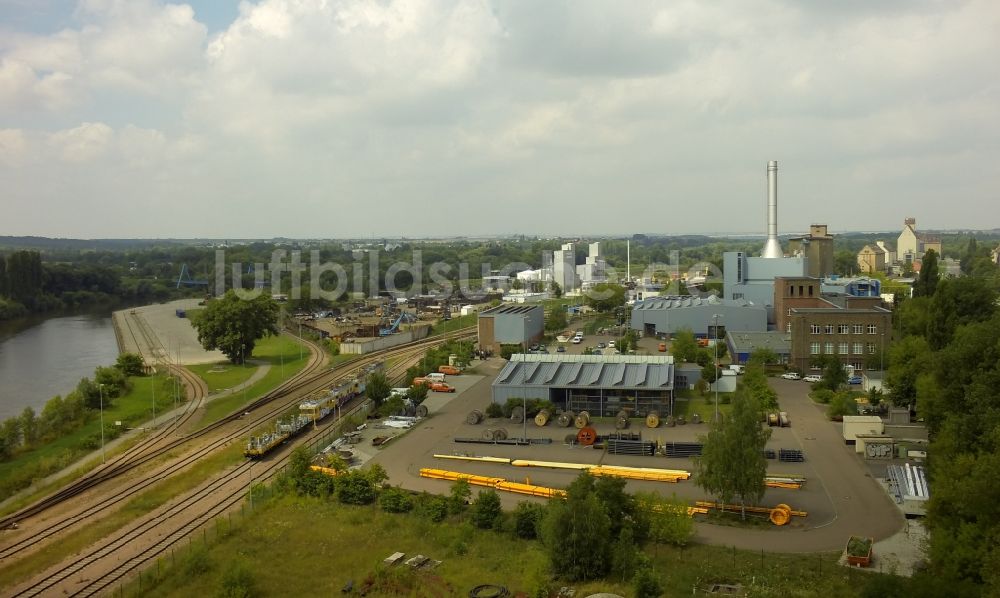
xmin=695 ymin=395 xmax=771 ymax=518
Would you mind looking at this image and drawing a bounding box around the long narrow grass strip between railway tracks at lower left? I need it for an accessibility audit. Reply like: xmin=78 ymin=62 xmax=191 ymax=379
xmin=0 ymin=443 xmax=243 ymax=588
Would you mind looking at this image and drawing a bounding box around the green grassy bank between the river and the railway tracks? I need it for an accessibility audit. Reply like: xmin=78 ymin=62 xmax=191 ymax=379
xmin=0 ymin=374 xmax=184 ymax=512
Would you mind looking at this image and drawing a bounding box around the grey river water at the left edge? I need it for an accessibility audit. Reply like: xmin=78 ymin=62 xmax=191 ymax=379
xmin=0 ymin=311 xmax=118 ymax=420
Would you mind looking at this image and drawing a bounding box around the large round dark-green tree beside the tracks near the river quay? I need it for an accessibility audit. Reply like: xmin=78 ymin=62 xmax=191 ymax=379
xmin=191 ymin=290 xmax=280 ymax=363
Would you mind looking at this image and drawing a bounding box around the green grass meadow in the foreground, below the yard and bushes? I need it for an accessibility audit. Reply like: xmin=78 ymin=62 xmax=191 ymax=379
xmin=124 ymin=494 xmax=877 ymax=598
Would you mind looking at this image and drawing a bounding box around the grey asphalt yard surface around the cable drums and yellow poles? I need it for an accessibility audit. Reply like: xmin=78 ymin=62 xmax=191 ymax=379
xmin=368 ymin=359 xmax=903 ymax=552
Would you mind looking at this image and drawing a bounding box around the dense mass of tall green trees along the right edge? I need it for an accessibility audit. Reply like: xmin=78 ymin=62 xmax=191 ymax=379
xmin=886 ymin=240 xmax=1000 ymax=596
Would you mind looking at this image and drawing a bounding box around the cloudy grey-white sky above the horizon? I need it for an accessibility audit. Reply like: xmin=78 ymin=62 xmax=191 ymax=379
xmin=0 ymin=0 xmax=1000 ymax=238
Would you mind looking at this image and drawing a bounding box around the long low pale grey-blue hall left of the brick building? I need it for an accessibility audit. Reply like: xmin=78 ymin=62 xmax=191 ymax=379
xmin=631 ymin=295 xmax=767 ymax=339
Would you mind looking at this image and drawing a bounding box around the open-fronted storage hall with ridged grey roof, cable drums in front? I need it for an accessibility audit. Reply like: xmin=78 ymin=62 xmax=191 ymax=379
xmin=493 ymin=353 xmax=674 ymax=417
